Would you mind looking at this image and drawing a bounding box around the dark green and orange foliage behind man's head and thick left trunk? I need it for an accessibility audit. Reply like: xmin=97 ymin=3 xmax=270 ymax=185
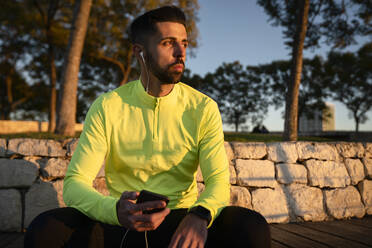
xmin=0 ymin=0 xmax=199 ymax=121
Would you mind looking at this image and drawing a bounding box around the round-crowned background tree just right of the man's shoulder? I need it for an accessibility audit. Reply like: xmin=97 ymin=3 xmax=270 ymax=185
xmin=206 ymin=61 xmax=268 ymax=132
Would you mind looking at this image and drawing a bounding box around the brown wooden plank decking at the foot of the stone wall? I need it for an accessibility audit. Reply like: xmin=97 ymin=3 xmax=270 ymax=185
xmin=0 ymin=216 xmax=372 ymax=248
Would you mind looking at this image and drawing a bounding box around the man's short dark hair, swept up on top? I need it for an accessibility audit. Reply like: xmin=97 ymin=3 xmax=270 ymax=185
xmin=129 ymin=5 xmax=186 ymax=45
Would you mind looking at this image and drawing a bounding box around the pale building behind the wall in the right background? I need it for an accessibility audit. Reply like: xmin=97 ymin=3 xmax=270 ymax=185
xmin=298 ymin=103 xmax=335 ymax=132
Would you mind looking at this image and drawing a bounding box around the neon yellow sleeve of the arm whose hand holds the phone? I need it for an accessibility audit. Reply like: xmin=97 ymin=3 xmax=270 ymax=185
xmin=63 ymin=96 xmax=120 ymax=225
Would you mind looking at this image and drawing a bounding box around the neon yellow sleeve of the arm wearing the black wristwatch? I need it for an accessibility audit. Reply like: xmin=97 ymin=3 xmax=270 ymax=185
xmin=192 ymin=101 xmax=230 ymax=227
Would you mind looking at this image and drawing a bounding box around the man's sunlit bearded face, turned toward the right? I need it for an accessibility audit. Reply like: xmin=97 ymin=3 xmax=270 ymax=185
xmin=145 ymin=22 xmax=188 ymax=84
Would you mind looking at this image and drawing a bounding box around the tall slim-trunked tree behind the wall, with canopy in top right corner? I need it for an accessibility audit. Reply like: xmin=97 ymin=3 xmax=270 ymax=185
xmin=257 ymin=0 xmax=372 ymax=140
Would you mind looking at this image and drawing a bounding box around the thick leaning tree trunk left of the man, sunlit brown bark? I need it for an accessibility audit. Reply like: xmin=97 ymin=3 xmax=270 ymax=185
xmin=56 ymin=0 xmax=92 ymax=136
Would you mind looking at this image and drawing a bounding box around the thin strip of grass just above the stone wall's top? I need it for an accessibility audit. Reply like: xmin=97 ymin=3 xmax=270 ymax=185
xmin=0 ymin=132 xmax=340 ymax=142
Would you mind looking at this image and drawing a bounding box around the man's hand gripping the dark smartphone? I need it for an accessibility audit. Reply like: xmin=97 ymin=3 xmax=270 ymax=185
xmin=116 ymin=191 xmax=170 ymax=232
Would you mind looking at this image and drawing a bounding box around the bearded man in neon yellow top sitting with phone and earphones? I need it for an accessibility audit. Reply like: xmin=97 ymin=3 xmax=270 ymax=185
xmin=25 ymin=6 xmax=271 ymax=248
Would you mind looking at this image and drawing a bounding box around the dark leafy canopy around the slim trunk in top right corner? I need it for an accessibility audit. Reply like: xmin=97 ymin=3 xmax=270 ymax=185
xmin=257 ymin=0 xmax=372 ymax=49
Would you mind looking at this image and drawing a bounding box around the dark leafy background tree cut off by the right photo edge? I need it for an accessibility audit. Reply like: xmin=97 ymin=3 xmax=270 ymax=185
xmin=326 ymin=43 xmax=372 ymax=132
